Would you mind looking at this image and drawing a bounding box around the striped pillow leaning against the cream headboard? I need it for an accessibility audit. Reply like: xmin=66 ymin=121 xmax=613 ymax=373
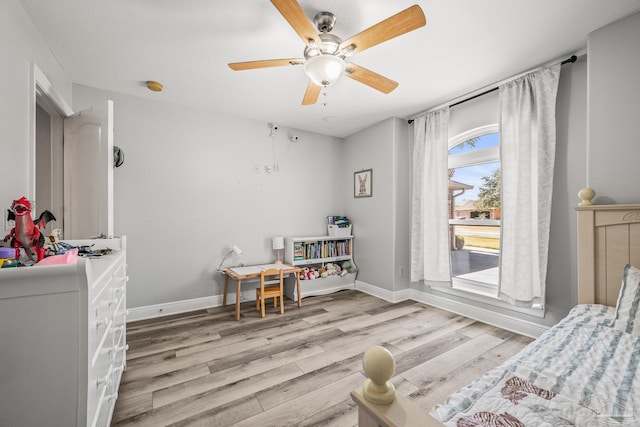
xmin=613 ymin=264 xmax=640 ymax=336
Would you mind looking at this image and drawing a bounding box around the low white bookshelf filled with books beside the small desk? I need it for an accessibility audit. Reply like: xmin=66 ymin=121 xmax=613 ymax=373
xmin=284 ymin=236 xmax=356 ymax=300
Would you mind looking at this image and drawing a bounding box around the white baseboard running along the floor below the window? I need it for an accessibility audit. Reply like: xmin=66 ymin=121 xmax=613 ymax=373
xmin=356 ymin=280 xmax=549 ymax=338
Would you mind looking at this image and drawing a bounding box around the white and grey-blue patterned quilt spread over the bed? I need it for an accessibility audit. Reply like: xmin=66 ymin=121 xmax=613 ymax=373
xmin=431 ymin=304 xmax=640 ymax=427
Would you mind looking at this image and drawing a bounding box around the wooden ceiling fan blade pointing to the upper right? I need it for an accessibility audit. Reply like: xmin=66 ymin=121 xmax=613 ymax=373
xmin=339 ymin=4 xmax=427 ymax=55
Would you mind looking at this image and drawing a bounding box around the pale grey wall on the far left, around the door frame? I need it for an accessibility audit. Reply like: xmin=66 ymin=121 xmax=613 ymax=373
xmin=0 ymin=0 xmax=71 ymax=217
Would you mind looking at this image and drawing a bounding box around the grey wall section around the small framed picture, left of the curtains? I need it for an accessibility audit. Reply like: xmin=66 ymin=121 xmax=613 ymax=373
xmin=340 ymin=118 xmax=411 ymax=295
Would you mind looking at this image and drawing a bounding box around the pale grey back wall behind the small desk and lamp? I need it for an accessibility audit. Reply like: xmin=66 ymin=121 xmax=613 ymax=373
xmin=73 ymin=85 xmax=342 ymax=307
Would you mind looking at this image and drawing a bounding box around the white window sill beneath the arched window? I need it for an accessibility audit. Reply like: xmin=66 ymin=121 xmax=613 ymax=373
xmin=432 ymin=277 xmax=544 ymax=319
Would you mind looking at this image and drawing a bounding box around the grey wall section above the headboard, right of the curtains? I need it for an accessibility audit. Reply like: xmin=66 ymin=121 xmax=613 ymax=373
xmin=585 ymin=10 xmax=640 ymax=204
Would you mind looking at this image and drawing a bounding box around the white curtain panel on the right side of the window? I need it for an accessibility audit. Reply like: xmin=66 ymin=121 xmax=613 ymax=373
xmin=498 ymin=64 xmax=560 ymax=307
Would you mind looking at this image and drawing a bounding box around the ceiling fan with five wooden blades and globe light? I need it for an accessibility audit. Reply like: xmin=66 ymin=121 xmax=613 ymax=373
xmin=229 ymin=0 xmax=427 ymax=105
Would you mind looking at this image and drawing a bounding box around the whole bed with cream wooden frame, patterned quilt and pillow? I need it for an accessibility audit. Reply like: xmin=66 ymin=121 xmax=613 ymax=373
xmin=352 ymin=199 xmax=640 ymax=427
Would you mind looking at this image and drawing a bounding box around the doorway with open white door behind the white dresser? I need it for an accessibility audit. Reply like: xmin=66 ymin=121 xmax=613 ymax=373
xmin=27 ymin=63 xmax=113 ymax=239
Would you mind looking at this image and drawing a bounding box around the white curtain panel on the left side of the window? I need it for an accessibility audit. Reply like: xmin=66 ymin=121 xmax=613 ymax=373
xmin=411 ymin=107 xmax=451 ymax=286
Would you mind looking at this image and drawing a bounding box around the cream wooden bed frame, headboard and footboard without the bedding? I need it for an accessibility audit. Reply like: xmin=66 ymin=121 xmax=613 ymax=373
xmin=351 ymin=197 xmax=640 ymax=427
